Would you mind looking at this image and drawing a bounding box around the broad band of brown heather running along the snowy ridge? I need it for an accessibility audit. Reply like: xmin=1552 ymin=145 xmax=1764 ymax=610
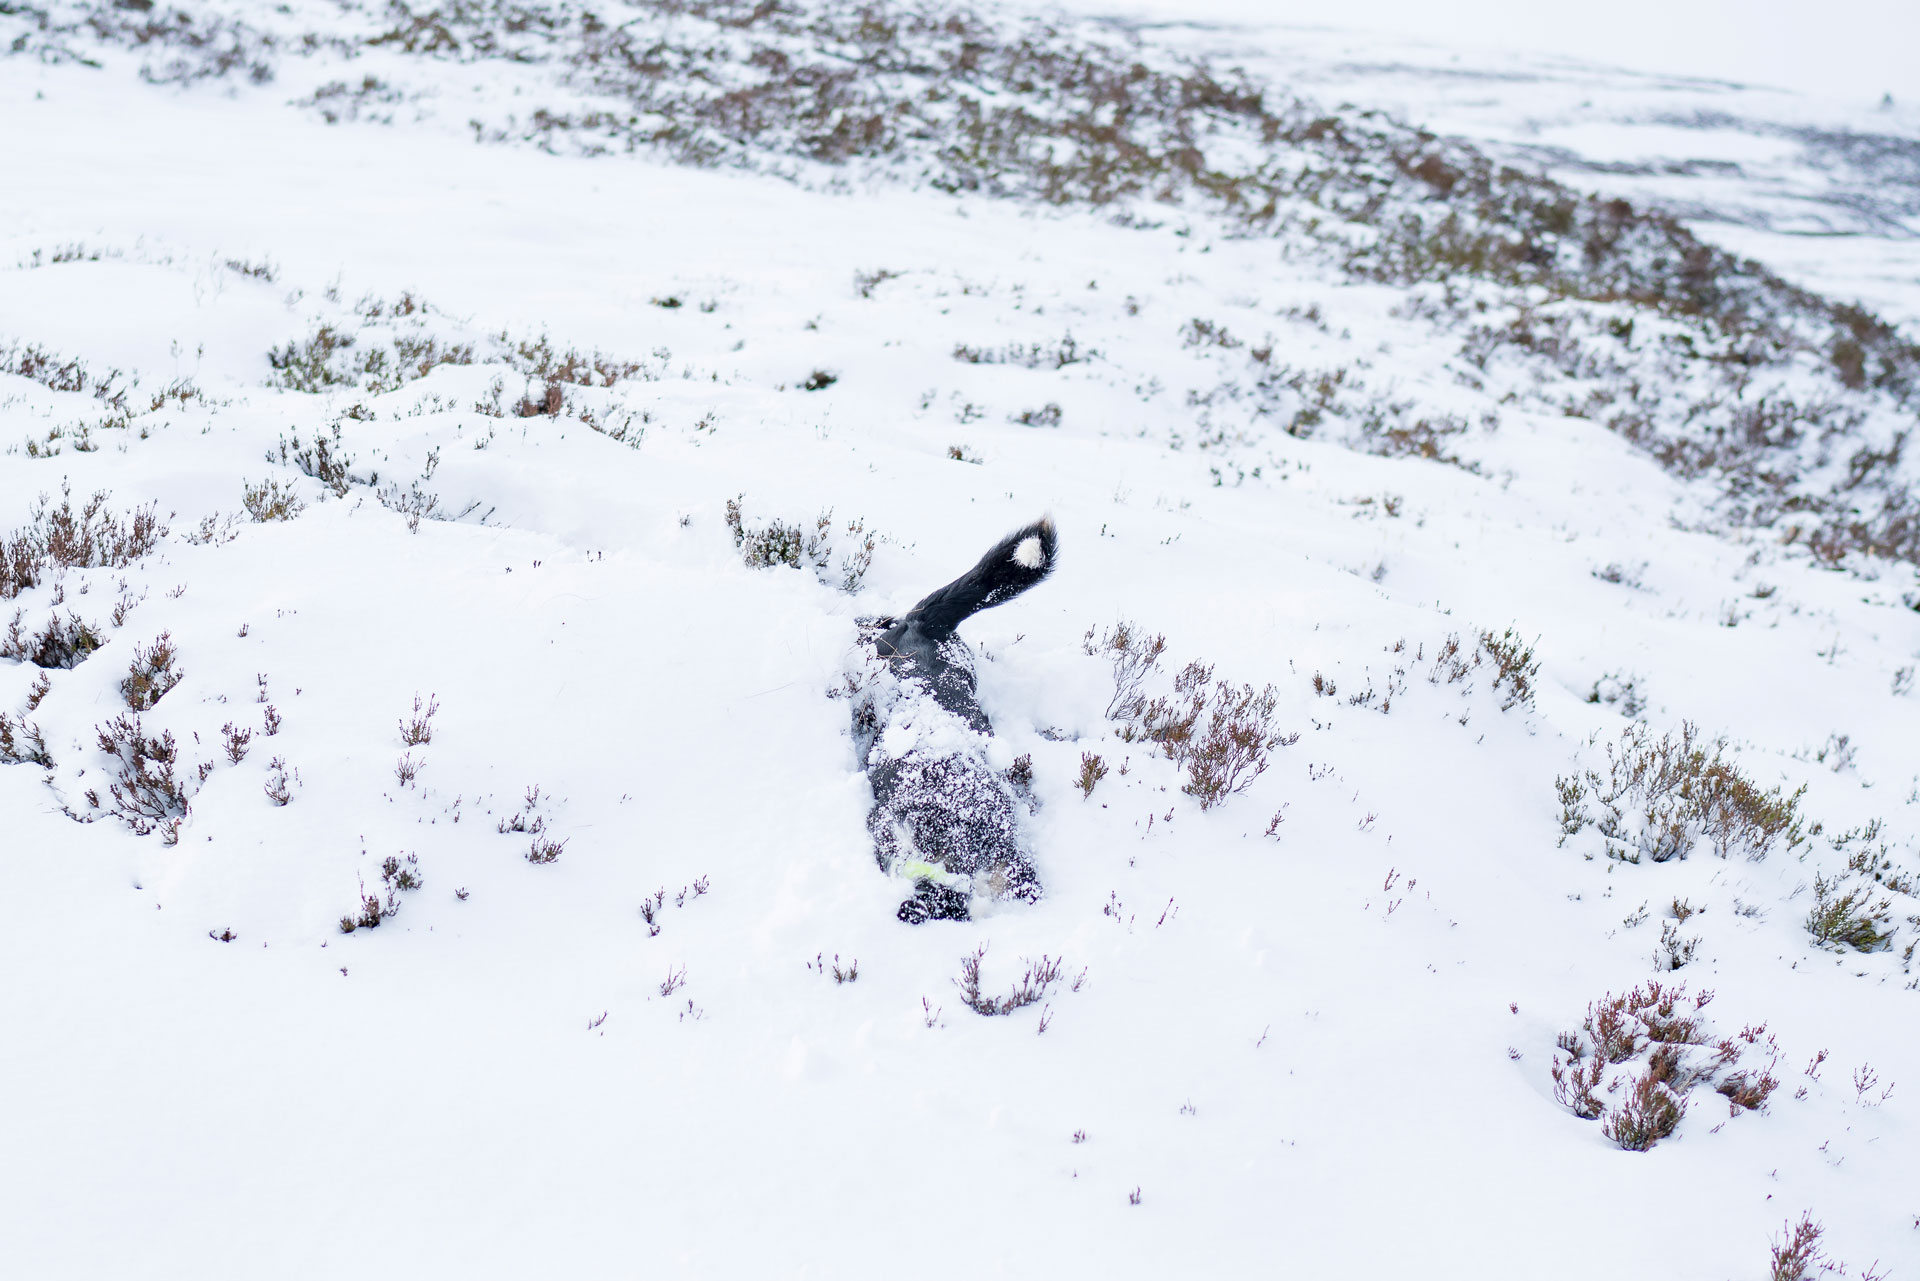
xmin=30 ymin=0 xmax=1920 ymax=567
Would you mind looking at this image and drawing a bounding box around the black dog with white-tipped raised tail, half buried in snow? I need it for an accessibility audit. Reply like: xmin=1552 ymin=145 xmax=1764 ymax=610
xmin=854 ymin=517 xmax=1058 ymax=924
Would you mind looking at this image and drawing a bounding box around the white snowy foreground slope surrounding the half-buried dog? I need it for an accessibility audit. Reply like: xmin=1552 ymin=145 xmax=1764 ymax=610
xmin=0 ymin=6 xmax=1920 ymax=1279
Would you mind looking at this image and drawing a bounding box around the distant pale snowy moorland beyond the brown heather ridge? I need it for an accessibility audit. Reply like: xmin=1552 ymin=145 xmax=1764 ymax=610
xmin=1136 ymin=18 xmax=1920 ymax=323
